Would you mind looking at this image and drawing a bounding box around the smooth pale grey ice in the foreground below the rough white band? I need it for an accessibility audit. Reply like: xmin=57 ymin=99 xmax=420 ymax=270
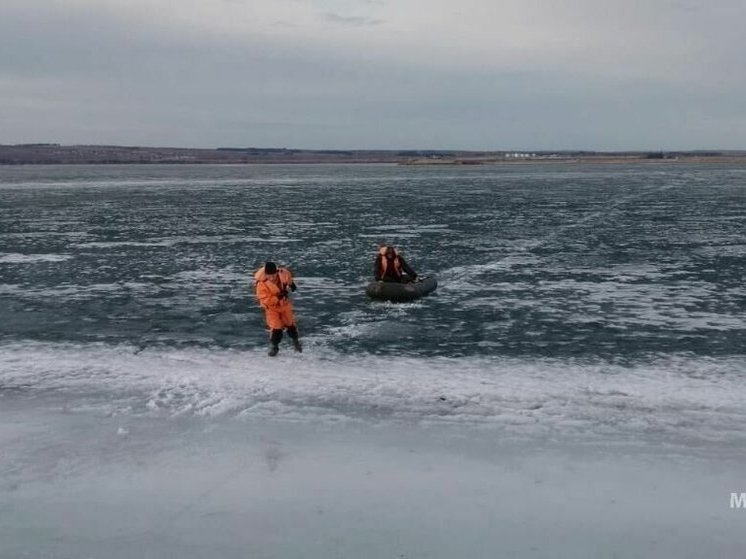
xmin=0 ymin=402 xmax=746 ymax=559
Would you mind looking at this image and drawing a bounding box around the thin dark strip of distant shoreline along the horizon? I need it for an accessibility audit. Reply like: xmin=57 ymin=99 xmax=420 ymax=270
xmin=0 ymin=144 xmax=746 ymax=166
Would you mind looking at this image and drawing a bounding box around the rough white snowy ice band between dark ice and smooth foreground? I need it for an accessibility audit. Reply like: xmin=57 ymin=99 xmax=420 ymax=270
xmin=0 ymin=339 xmax=746 ymax=443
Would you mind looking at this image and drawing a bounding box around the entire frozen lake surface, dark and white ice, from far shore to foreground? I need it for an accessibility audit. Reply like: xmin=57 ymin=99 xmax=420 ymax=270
xmin=0 ymin=164 xmax=746 ymax=559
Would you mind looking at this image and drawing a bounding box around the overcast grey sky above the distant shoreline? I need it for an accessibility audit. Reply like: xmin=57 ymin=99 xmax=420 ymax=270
xmin=0 ymin=0 xmax=746 ymax=150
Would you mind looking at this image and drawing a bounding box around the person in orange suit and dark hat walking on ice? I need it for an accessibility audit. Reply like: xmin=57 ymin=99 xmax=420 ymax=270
xmin=254 ymin=262 xmax=303 ymax=357
